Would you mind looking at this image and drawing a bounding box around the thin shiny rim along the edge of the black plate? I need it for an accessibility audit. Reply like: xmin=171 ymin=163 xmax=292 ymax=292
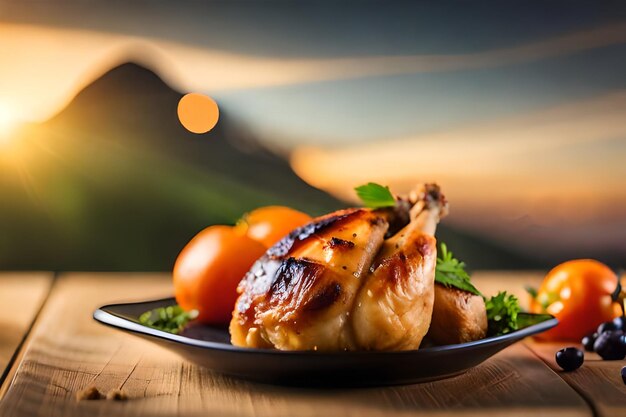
xmin=93 ymin=297 xmax=558 ymax=357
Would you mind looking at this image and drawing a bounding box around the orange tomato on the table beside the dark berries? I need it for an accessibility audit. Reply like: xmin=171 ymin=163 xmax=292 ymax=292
xmin=531 ymin=259 xmax=618 ymax=341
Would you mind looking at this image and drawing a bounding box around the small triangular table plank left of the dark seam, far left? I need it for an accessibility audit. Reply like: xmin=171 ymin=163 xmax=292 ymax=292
xmin=0 ymin=272 xmax=53 ymax=381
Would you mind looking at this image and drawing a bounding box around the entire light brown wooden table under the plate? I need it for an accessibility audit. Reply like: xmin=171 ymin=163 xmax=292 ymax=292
xmin=0 ymin=272 xmax=626 ymax=417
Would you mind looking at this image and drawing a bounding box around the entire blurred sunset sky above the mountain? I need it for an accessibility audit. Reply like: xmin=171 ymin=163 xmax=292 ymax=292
xmin=0 ymin=1 xmax=626 ymax=264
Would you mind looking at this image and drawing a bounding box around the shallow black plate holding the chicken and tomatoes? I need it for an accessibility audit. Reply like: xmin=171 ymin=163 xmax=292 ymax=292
xmin=93 ymin=298 xmax=558 ymax=386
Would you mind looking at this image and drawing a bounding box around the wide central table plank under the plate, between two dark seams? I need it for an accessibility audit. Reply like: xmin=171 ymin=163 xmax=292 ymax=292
xmin=0 ymin=274 xmax=591 ymax=417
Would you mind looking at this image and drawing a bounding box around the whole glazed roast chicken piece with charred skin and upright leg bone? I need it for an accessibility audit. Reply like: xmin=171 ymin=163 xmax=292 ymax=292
xmin=230 ymin=184 xmax=447 ymax=351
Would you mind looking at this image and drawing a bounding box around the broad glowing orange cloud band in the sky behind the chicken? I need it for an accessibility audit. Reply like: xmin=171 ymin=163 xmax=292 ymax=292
xmin=291 ymin=91 xmax=626 ymax=258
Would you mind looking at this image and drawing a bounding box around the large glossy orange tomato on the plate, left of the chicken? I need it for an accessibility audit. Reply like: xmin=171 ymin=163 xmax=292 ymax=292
xmin=174 ymin=226 xmax=266 ymax=324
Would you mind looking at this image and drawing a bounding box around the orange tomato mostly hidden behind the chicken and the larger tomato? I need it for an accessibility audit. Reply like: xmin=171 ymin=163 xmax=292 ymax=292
xmin=235 ymin=206 xmax=312 ymax=248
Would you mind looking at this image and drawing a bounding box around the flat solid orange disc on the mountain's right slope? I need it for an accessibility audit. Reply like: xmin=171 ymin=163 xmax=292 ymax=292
xmin=178 ymin=93 xmax=220 ymax=134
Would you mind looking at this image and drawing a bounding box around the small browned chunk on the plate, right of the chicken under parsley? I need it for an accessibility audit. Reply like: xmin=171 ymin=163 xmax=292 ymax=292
xmin=426 ymin=284 xmax=487 ymax=345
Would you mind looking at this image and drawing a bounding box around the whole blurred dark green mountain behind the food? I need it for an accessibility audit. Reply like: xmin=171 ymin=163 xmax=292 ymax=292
xmin=0 ymin=63 xmax=534 ymax=271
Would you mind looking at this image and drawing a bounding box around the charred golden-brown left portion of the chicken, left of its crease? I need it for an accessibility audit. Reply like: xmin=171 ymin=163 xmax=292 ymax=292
xmin=230 ymin=209 xmax=388 ymax=350
